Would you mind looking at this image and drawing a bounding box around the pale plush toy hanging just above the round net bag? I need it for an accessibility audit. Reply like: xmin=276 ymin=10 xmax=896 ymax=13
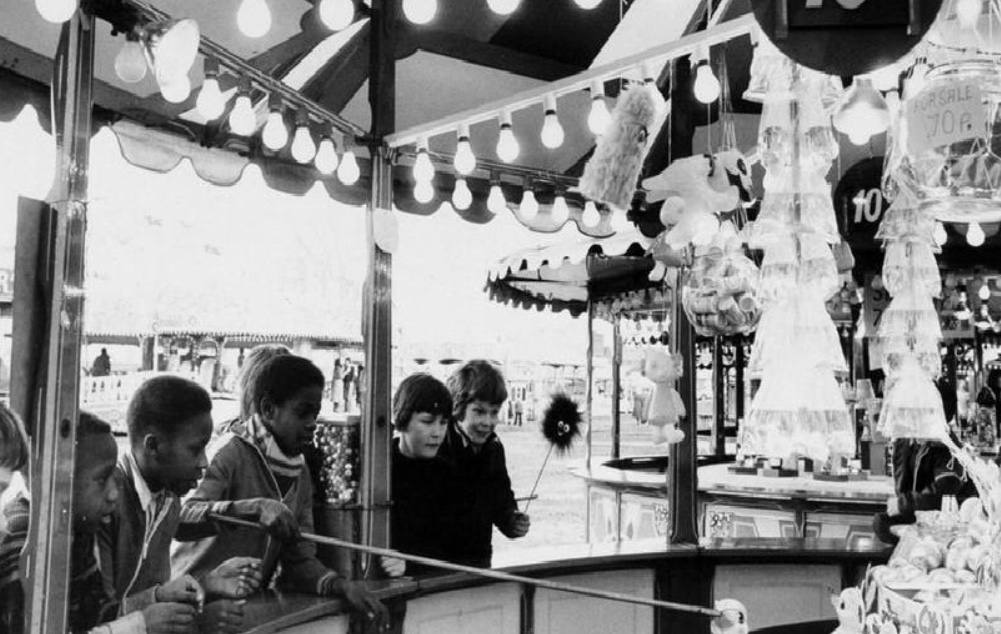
xmin=643 ymin=149 xmax=751 ymax=248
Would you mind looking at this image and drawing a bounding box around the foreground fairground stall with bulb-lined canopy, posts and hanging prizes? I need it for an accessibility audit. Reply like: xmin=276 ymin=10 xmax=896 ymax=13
xmin=0 ymin=0 xmax=1001 ymax=634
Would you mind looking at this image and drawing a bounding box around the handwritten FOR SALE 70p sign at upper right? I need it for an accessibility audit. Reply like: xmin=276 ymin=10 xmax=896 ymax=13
xmin=907 ymin=79 xmax=987 ymax=154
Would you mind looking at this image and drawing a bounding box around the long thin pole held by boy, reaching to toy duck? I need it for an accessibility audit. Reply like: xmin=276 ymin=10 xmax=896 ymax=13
xmin=209 ymin=513 xmax=721 ymax=617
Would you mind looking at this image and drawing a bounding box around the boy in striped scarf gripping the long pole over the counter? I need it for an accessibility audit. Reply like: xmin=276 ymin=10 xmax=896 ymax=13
xmin=173 ymin=355 xmax=385 ymax=621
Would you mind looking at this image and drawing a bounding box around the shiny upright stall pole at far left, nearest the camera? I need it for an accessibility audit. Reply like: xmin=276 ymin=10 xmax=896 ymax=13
xmin=25 ymin=11 xmax=94 ymax=634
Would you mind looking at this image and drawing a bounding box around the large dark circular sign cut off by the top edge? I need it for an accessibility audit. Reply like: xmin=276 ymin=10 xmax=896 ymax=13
xmin=752 ymin=0 xmax=942 ymax=77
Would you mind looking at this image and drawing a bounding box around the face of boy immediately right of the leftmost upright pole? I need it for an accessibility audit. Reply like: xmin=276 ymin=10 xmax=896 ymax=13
xmin=73 ymin=434 xmax=118 ymax=533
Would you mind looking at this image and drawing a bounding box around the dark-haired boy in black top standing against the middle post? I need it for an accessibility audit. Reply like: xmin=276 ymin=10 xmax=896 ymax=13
xmin=381 ymin=374 xmax=454 ymax=577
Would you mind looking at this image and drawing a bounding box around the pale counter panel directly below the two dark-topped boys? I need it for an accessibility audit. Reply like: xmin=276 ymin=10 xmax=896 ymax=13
xmin=403 ymin=583 xmax=522 ymax=634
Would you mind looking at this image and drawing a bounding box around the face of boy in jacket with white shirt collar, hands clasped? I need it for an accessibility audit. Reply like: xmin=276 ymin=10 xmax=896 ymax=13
xmin=146 ymin=412 xmax=212 ymax=496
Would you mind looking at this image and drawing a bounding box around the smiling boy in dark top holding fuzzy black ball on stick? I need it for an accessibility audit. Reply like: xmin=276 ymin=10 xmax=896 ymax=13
xmin=441 ymin=360 xmax=532 ymax=568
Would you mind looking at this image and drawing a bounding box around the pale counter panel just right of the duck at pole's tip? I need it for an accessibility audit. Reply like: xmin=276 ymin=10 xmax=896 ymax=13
xmin=713 ymin=565 xmax=841 ymax=630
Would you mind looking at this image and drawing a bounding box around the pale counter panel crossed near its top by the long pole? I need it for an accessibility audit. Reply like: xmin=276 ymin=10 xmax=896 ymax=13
xmin=536 ymin=569 xmax=654 ymax=634
